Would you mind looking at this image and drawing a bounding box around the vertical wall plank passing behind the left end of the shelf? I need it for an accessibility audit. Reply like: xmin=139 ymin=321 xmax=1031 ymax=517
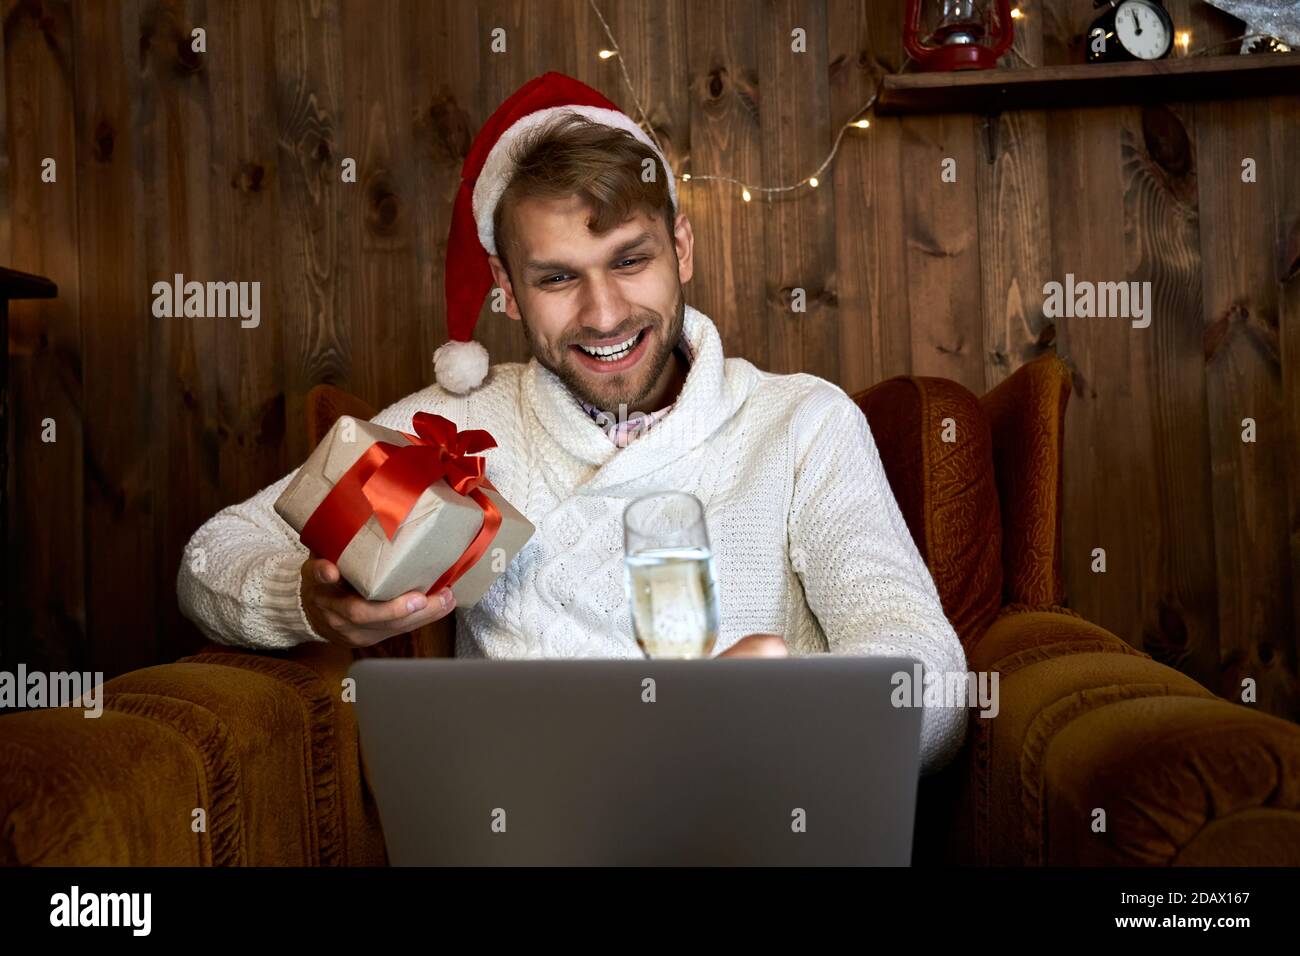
xmin=827 ymin=0 xmax=911 ymax=394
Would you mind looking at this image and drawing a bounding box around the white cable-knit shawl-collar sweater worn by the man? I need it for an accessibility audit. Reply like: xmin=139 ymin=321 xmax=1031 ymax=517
xmin=178 ymin=306 xmax=966 ymax=773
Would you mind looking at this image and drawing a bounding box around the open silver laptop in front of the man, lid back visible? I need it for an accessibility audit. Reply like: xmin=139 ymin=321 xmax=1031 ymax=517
xmin=350 ymin=656 xmax=922 ymax=866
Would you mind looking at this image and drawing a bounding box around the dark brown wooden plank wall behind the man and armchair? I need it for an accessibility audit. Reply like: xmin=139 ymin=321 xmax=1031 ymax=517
xmin=0 ymin=0 xmax=1300 ymax=718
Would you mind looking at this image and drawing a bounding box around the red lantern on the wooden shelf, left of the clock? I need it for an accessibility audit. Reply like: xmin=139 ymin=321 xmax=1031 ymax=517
xmin=902 ymin=0 xmax=1015 ymax=70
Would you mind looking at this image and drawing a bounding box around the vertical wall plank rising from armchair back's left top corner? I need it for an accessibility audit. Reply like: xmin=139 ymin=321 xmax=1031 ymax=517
xmin=274 ymin=0 xmax=352 ymax=463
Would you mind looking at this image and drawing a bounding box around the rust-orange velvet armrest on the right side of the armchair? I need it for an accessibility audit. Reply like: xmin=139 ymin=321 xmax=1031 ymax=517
xmin=935 ymin=606 xmax=1300 ymax=866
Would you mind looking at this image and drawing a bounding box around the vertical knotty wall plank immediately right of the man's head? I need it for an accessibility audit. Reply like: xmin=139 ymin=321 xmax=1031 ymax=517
xmin=681 ymin=0 xmax=772 ymax=368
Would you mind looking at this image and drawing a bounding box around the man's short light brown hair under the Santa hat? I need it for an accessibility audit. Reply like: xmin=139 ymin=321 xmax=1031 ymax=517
xmin=493 ymin=113 xmax=675 ymax=273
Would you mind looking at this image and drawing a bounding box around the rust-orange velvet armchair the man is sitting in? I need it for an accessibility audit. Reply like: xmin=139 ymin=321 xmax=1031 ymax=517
xmin=0 ymin=356 xmax=1300 ymax=866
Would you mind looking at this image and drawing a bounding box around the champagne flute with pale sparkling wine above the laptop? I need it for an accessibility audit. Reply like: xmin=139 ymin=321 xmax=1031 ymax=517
xmin=623 ymin=492 xmax=719 ymax=658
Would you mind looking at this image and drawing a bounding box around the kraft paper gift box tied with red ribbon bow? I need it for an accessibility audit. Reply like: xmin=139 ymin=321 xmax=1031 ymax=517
xmin=276 ymin=412 xmax=534 ymax=607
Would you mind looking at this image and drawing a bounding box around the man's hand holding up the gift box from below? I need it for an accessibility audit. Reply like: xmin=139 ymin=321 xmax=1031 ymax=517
xmin=302 ymin=557 xmax=456 ymax=648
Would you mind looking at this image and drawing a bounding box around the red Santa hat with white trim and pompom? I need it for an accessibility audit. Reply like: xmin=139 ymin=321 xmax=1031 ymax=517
xmin=433 ymin=73 xmax=677 ymax=393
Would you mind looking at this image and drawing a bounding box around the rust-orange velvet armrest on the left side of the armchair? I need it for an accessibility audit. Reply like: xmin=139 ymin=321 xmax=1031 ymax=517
xmin=0 ymin=644 xmax=386 ymax=865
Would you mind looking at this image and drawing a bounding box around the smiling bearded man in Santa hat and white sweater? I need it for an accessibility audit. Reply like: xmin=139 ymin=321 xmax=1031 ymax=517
xmin=178 ymin=74 xmax=966 ymax=770
